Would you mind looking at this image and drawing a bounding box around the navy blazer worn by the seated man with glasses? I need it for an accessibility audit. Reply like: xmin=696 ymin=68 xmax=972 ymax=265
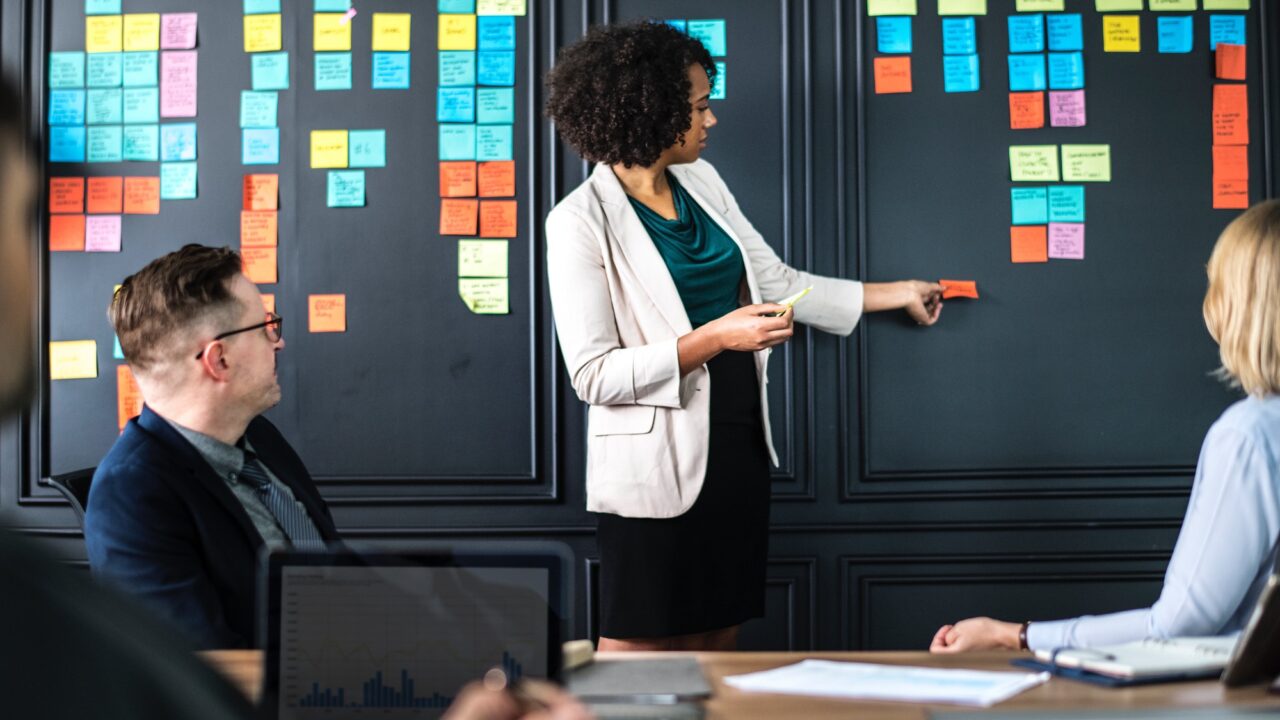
xmin=84 ymin=407 xmax=338 ymax=648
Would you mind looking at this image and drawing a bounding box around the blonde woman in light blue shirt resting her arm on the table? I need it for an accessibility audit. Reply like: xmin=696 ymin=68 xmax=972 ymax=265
xmin=929 ymin=200 xmax=1280 ymax=652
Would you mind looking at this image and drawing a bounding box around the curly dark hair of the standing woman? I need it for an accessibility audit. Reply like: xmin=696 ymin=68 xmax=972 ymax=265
xmin=547 ymin=19 xmax=716 ymax=168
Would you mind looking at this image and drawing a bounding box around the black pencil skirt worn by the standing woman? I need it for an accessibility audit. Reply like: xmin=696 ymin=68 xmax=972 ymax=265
xmin=596 ymin=351 xmax=769 ymax=639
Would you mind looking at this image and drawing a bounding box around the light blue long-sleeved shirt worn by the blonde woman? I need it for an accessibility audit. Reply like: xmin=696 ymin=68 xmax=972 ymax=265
xmin=1027 ymin=396 xmax=1280 ymax=650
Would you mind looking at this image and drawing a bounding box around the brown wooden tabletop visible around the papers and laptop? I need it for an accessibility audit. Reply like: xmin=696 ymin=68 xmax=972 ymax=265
xmin=202 ymin=650 xmax=1280 ymax=720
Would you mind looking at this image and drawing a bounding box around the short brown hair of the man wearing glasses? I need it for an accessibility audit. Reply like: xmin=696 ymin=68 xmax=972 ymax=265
xmin=106 ymin=245 xmax=244 ymax=372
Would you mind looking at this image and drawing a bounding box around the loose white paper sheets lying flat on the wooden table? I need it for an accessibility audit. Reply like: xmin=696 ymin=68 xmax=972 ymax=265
xmin=724 ymin=660 xmax=1048 ymax=707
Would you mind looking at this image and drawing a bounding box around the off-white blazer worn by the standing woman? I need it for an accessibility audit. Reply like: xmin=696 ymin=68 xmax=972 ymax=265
xmin=547 ymin=160 xmax=863 ymax=518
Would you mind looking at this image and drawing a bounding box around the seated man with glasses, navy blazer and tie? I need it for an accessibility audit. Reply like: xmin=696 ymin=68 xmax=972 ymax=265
xmin=84 ymin=245 xmax=338 ymax=648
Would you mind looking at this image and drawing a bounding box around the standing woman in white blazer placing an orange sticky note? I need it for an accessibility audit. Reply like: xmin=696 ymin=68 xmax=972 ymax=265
xmin=547 ymin=22 xmax=942 ymax=650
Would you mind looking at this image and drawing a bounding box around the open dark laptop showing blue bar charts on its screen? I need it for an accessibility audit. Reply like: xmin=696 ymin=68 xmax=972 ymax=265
xmin=260 ymin=543 xmax=571 ymax=720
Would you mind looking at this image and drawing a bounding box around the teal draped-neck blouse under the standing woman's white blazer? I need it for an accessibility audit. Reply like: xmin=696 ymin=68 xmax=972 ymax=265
xmin=627 ymin=173 xmax=745 ymax=328
